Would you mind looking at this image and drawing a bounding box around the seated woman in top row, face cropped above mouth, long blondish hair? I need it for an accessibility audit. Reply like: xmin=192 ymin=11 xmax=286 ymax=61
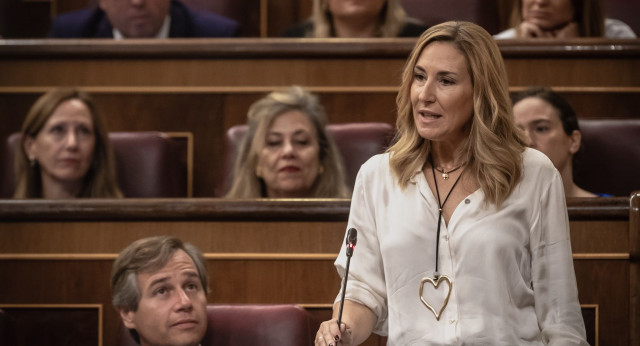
xmin=283 ymin=0 xmax=427 ymax=38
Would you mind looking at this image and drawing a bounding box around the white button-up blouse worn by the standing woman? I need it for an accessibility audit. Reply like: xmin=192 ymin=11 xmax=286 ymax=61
xmin=335 ymin=149 xmax=588 ymax=346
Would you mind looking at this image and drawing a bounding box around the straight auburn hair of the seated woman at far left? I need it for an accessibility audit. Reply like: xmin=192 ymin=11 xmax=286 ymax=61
xmin=13 ymin=88 xmax=122 ymax=198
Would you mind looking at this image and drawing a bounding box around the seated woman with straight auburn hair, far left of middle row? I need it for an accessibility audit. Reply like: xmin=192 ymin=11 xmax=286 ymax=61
xmin=14 ymin=88 xmax=122 ymax=199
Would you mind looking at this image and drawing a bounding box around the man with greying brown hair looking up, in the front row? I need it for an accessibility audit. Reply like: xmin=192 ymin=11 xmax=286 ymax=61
xmin=111 ymin=236 xmax=208 ymax=346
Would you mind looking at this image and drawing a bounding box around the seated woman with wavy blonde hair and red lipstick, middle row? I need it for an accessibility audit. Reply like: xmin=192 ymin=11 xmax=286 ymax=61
xmin=226 ymin=86 xmax=349 ymax=198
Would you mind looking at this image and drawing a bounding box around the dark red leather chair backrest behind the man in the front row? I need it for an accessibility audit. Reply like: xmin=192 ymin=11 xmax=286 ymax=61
xmin=118 ymin=304 xmax=315 ymax=346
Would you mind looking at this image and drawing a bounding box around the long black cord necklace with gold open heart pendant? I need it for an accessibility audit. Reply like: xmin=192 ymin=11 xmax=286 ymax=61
xmin=418 ymin=156 xmax=462 ymax=321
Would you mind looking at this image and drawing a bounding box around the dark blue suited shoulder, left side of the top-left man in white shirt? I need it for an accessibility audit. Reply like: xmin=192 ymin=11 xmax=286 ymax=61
xmin=49 ymin=6 xmax=107 ymax=38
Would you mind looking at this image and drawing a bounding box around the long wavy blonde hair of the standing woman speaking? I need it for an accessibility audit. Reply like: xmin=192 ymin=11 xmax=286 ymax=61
xmin=387 ymin=22 xmax=525 ymax=207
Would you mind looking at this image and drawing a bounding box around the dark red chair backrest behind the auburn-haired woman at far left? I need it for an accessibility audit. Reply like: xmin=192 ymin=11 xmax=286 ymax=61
xmin=0 ymin=131 xmax=189 ymax=198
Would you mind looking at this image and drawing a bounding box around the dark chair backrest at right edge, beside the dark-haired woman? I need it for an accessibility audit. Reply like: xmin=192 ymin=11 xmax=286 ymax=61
xmin=574 ymin=119 xmax=640 ymax=197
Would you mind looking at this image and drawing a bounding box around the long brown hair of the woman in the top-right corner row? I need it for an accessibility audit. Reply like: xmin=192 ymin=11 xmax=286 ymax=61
xmin=509 ymin=0 xmax=605 ymax=37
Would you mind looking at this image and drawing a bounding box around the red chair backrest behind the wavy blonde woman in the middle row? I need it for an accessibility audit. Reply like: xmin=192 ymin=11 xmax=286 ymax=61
xmin=216 ymin=122 xmax=394 ymax=196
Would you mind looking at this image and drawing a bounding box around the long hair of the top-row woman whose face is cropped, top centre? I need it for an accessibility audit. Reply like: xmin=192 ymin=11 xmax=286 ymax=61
xmin=311 ymin=0 xmax=407 ymax=38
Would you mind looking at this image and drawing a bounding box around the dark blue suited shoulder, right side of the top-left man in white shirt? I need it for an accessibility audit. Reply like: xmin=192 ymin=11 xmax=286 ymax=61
xmin=170 ymin=0 xmax=239 ymax=37
